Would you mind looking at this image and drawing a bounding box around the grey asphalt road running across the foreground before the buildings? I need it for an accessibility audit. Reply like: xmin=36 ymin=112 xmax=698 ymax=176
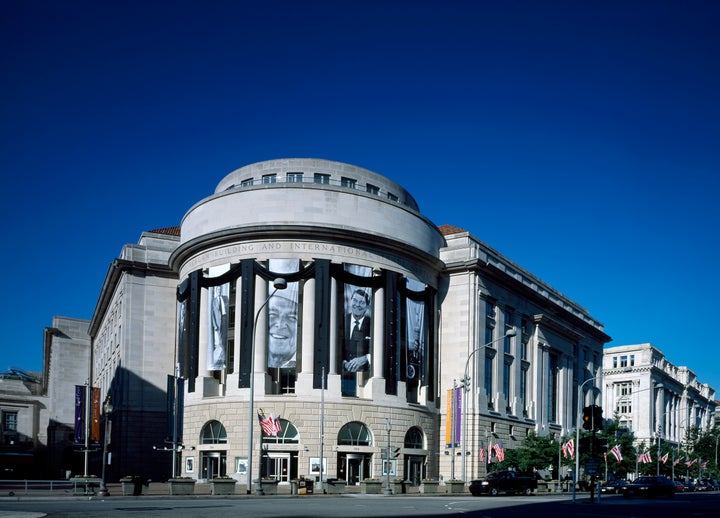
xmin=0 ymin=493 xmax=720 ymax=518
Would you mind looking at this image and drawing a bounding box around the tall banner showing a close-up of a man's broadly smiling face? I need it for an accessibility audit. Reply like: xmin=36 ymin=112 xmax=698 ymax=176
xmin=267 ymin=259 xmax=300 ymax=369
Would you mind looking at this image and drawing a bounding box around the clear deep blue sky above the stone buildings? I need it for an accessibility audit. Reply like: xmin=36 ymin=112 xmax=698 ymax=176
xmin=0 ymin=0 xmax=720 ymax=396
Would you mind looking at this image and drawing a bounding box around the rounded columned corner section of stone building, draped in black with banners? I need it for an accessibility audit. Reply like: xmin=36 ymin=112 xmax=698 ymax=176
xmin=170 ymin=159 xmax=444 ymax=484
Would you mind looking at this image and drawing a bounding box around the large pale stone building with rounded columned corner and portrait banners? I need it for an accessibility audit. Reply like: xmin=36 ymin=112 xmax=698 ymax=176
xmin=60 ymin=159 xmax=609 ymax=484
